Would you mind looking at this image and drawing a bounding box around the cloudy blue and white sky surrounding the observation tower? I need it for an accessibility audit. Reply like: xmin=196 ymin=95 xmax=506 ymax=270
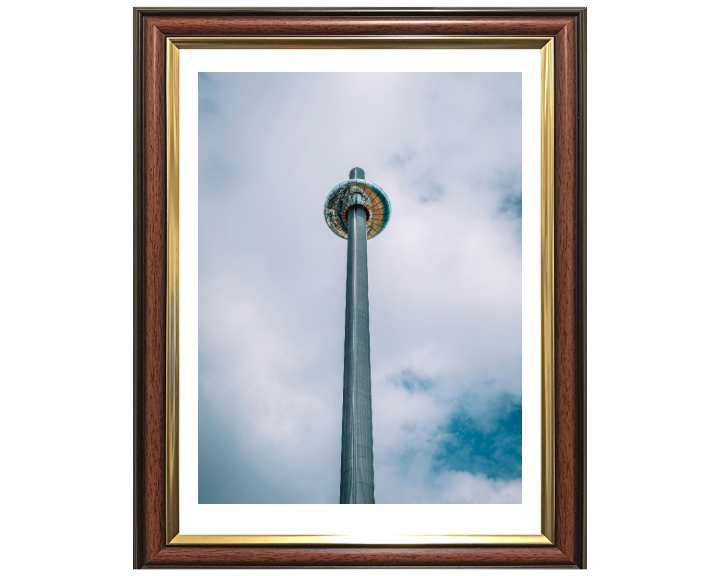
xmin=198 ymin=73 xmax=522 ymax=504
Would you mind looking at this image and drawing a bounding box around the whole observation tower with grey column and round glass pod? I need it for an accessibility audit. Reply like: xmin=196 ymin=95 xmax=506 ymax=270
xmin=323 ymin=168 xmax=391 ymax=504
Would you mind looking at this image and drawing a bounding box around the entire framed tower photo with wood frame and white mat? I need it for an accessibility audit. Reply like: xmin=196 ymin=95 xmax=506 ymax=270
xmin=134 ymin=8 xmax=586 ymax=568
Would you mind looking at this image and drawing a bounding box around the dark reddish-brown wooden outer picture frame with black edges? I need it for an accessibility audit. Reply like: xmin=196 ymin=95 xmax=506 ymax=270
xmin=134 ymin=8 xmax=586 ymax=568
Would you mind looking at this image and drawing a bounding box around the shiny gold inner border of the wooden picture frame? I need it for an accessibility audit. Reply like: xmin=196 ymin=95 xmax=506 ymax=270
xmin=165 ymin=36 xmax=555 ymax=546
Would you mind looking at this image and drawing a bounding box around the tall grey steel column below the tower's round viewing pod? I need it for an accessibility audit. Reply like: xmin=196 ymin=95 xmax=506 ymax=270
xmin=340 ymin=205 xmax=375 ymax=504
